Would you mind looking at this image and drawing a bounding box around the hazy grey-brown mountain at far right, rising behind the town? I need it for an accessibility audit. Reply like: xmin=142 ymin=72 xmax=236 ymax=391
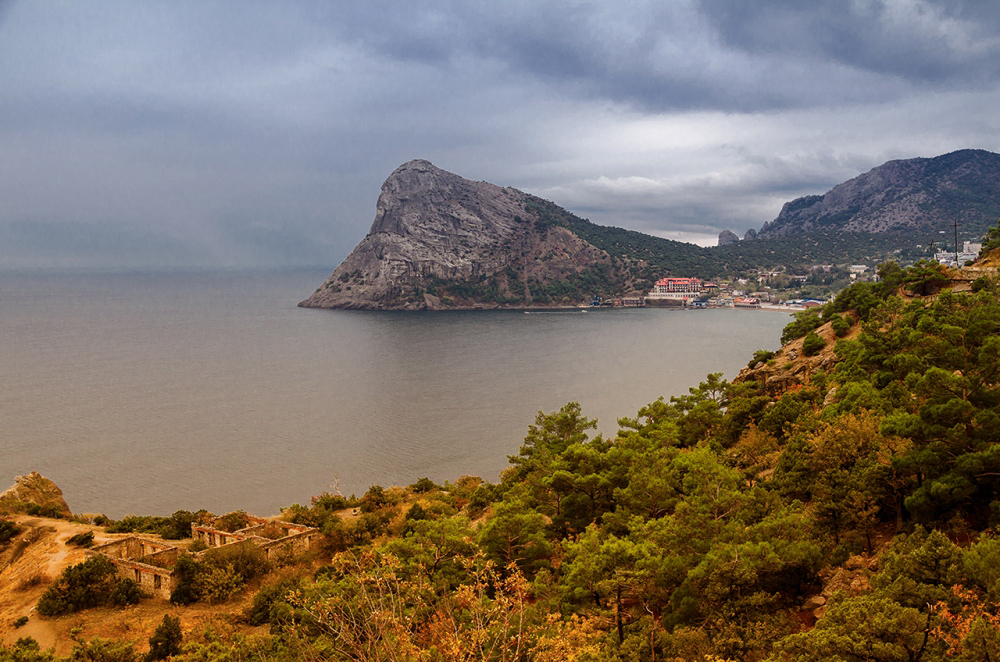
xmin=758 ymin=149 xmax=1000 ymax=239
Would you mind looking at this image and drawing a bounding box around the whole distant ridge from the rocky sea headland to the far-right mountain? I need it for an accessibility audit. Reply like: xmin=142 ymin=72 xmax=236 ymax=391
xmin=299 ymin=150 xmax=1000 ymax=310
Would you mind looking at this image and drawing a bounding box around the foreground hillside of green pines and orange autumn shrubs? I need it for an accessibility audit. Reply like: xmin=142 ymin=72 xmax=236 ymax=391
xmin=9 ymin=265 xmax=1000 ymax=662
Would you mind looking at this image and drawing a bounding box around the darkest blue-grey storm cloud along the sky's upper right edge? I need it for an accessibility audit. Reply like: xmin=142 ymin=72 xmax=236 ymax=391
xmin=327 ymin=0 xmax=1000 ymax=111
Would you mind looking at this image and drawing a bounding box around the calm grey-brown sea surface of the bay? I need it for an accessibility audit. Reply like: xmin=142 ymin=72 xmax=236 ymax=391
xmin=0 ymin=269 xmax=789 ymax=518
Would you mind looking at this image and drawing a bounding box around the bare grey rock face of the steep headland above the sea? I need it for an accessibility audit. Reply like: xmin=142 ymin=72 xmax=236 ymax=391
xmin=299 ymin=160 xmax=611 ymax=310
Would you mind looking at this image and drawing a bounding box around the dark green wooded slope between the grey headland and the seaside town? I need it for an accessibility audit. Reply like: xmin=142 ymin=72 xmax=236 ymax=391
xmin=411 ymin=195 xmax=987 ymax=306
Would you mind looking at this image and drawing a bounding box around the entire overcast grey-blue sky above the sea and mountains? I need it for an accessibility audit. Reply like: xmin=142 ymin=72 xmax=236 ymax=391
xmin=0 ymin=0 xmax=1000 ymax=269
